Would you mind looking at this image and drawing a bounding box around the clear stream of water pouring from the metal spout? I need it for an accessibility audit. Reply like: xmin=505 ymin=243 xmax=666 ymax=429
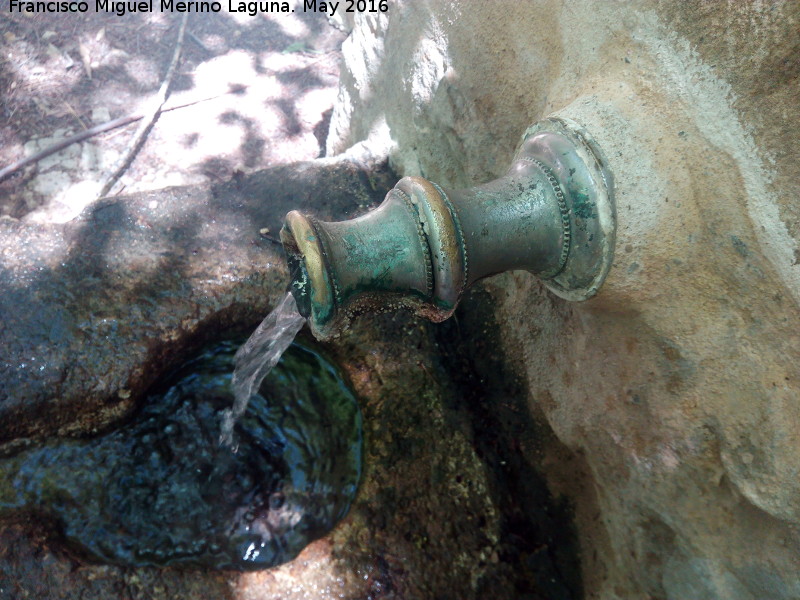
xmin=219 ymin=292 xmax=306 ymax=448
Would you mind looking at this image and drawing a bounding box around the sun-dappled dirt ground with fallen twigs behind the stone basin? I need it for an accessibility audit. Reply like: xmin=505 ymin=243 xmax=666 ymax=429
xmin=0 ymin=3 xmax=345 ymax=222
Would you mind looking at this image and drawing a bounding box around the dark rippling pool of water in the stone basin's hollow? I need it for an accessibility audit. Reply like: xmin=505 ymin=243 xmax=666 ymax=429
xmin=0 ymin=342 xmax=361 ymax=570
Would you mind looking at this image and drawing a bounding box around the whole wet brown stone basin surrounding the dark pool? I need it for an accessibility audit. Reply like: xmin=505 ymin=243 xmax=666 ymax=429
xmin=0 ymin=160 xmax=581 ymax=599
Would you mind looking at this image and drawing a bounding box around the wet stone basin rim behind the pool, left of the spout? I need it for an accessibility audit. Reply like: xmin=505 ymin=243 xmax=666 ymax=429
xmin=0 ymin=160 xmax=394 ymax=445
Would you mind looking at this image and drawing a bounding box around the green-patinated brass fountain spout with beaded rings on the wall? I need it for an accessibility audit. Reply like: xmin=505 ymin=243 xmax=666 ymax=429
xmin=281 ymin=118 xmax=616 ymax=339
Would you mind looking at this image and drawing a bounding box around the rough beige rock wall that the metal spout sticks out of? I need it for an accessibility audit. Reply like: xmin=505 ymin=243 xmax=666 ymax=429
xmin=328 ymin=0 xmax=800 ymax=600
